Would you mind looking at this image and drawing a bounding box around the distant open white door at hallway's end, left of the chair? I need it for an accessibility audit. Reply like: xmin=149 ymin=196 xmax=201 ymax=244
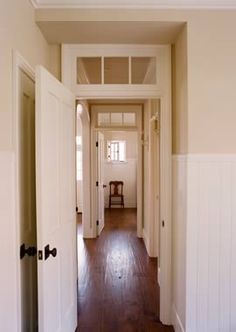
xmin=96 ymin=132 xmax=105 ymax=235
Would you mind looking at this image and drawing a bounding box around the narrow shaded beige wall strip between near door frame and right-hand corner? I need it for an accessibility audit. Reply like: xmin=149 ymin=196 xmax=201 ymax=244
xmin=172 ymin=25 xmax=188 ymax=154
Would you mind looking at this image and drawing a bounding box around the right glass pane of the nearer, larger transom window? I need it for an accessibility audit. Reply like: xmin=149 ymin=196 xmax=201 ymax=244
xmin=131 ymin=57 xmax=156 ymax=84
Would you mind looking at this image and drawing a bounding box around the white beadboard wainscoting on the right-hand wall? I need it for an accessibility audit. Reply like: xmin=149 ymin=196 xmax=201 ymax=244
xmin=186 ymin=155 xmax=236 ymax=332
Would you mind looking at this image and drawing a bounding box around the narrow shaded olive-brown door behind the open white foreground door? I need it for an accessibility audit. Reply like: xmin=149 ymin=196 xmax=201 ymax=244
xmin=18 ymin=70 xmax=37 ymax=332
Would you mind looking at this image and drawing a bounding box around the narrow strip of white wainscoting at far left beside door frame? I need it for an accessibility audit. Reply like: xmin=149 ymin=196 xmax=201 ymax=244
xmin=0 ymin=151 xmax=19 ymax=331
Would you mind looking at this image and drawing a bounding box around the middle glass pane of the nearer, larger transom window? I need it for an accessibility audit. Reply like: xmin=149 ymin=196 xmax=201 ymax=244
xmin=104 ymin=57 xmax=129 ymax=84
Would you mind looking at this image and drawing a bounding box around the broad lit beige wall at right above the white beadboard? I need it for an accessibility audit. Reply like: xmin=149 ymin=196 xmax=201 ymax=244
xmin=188 ymin=11 xmax=236 ymax=153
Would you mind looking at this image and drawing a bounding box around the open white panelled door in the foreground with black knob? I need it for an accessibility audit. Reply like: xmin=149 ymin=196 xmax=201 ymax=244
xmin=36 ymin=67 xmax=77 ymax=332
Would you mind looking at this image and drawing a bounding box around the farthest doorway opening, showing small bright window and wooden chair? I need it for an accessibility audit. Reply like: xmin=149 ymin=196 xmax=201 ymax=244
xmin=103 ymin=130 xmax=138 ymax=229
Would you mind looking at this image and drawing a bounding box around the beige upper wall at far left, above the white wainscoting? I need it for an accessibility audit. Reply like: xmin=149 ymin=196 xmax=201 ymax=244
xmin=0 ymin=0 xmax=49 ymax=150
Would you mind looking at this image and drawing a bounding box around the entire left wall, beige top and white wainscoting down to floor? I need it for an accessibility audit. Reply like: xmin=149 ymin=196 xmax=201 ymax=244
xmin=0 ymin=0 xmax=49 ymax=332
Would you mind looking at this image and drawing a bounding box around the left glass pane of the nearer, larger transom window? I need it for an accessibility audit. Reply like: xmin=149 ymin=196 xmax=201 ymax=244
xmin=77 ymin=57 xmax=102 ymax=84
